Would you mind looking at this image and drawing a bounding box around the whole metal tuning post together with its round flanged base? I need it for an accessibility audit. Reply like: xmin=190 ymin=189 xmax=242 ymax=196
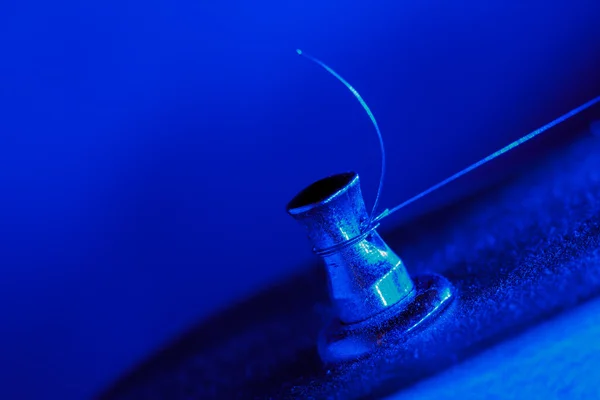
xmin=287 ymin=172 xmax=452 ymax=362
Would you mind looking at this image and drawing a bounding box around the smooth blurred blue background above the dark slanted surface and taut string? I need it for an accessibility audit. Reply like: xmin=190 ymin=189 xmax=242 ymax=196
xmin=0 ymin=0 xmax=600 ymax=399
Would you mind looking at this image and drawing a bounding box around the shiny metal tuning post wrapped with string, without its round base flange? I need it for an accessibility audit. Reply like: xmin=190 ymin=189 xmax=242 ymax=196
xmin=287 ymin=172 xmax=414 ymax=324
